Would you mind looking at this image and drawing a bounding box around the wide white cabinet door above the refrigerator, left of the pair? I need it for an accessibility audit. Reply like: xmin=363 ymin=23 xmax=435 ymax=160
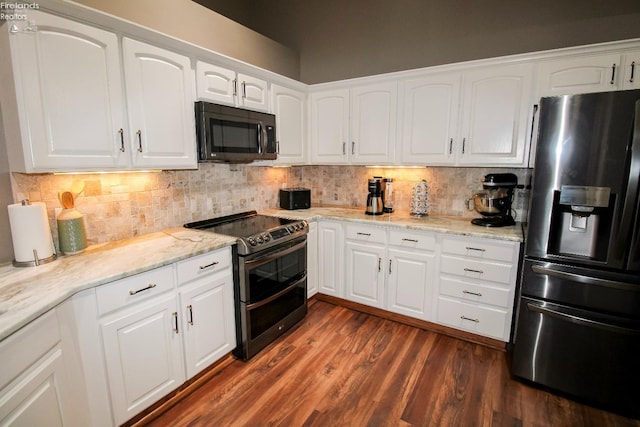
xmin=538 ymin=53 xmax=624 ymax=98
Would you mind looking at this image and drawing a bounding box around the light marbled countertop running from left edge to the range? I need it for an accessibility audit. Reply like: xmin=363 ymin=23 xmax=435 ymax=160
xmin=0 ymin=228 xmax=236 ymax=340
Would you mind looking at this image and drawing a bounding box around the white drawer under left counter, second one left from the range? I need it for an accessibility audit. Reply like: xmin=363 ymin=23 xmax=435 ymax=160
xmin=96 ymin=266 xmax=174 ymax=315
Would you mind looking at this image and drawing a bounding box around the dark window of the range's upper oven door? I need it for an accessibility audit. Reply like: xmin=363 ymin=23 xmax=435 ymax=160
xmin=246 ymin=245 xmax=307 ymax=304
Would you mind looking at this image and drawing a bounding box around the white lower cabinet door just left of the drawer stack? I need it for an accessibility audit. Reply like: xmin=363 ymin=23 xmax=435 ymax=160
xmin=387 ymin=248 xmax=436 ymax=320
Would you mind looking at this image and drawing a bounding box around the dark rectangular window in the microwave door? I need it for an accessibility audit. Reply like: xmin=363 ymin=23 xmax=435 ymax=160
xmin=209 ymin=118 xmax=259 ymax=153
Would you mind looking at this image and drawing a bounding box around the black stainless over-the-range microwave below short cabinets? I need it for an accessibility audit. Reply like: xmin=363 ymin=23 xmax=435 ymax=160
xmin=195 ymin=101 xmax=277 ymax=163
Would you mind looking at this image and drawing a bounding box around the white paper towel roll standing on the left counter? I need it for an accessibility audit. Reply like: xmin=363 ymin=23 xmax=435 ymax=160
xmin=8 ymin=202 xmax=55 ymax=265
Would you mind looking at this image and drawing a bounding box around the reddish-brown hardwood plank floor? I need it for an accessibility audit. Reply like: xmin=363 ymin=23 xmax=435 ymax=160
xmin=143 ymin=300 xmax=640 ymax=427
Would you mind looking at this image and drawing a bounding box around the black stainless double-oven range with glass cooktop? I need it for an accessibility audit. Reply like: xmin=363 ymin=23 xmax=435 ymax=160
xmin=185 ymin=211 xmax=309 ymax=360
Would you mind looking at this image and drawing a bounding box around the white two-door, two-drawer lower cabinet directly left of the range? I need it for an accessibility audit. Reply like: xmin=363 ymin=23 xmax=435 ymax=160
xmin=96 ymin=248 xmax=236 ymax=424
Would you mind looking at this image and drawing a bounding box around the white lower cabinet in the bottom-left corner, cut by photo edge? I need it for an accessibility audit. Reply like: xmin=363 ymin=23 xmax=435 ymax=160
xmin=0 ymin=310 xmax=82 ymax=426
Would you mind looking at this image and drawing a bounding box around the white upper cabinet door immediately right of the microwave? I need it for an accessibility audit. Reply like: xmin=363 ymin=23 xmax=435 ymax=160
xmin=271 ymin=84 xmax=307 ymax=164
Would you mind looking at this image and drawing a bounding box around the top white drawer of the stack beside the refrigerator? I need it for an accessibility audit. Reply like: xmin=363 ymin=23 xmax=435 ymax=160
xmin=442 ymin=238 xmax=519 ymax=263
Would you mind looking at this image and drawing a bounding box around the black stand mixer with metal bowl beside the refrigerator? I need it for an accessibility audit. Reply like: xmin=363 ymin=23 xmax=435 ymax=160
xmin=471 ymin=173 xmax=518 ymax=227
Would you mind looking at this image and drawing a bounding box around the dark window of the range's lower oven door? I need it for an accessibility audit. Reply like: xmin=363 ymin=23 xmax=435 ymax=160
xmin=248 ymin=280 xmax=307 ymax=340
